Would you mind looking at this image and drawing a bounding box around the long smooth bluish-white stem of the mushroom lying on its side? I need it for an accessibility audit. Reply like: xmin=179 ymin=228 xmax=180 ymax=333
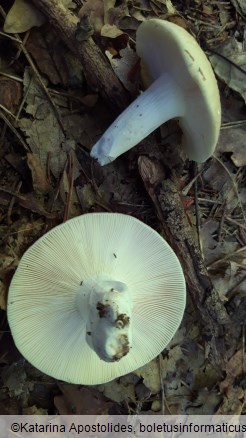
xmin=91 ymin=74 xmax=185 ymax=166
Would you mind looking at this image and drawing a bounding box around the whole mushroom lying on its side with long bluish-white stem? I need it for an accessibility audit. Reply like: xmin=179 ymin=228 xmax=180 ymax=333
xmin=91 ymin=19 xmax=221 ymax=166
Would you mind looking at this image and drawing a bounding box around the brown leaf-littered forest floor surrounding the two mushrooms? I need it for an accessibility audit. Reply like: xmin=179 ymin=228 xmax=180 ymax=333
xmin=0 ymin=0 xmax=246 ymax=414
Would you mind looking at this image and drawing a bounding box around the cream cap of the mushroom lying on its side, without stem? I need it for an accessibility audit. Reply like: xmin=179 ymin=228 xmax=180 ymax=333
xmin=136 ymin=19 xmax=221 ymax=163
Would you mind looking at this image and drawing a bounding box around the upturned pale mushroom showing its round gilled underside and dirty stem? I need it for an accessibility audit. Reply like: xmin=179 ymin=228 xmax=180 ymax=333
xmin=7 ymin=213 xmax=185 ymax=385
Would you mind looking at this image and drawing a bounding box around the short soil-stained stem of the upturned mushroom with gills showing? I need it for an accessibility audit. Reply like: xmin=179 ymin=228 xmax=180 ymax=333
xmin=86 ymin=281 xmax=132 ymax=362
